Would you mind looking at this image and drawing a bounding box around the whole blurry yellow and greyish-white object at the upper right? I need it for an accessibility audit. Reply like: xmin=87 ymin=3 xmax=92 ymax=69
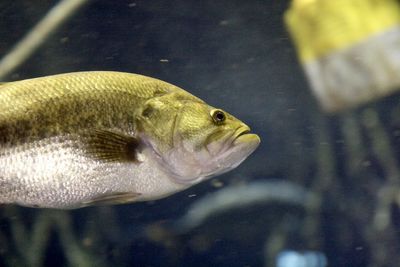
xmin=285 ymin=0 xmax=400 ymax=111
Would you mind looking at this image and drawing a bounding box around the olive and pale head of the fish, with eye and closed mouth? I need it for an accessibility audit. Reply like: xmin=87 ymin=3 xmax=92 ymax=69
xmin=139 ymin=94 xmax=260 ymax=184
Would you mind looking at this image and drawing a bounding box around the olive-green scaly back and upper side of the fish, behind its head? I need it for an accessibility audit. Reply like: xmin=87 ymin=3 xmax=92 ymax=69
xmin=0 ymin=72 xmax=177 ymax=147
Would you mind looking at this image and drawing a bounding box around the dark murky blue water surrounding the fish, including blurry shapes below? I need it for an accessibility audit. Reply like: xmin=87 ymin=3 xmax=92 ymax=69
xmin=0 ymin=0 xmax=400 ymax=267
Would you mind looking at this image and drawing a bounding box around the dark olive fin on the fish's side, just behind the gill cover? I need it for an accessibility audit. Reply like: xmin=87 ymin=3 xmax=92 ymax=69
xmin=83 ymin=130 xmax=140 ymax=162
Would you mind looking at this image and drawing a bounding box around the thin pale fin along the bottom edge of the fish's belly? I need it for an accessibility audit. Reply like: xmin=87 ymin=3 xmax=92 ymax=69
xmin=82 ymin=192 xmax=140 ymax=207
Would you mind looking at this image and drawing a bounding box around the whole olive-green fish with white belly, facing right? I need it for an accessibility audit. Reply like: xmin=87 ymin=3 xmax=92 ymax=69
xmin=0 ymin=71 xmax=260 ymax=209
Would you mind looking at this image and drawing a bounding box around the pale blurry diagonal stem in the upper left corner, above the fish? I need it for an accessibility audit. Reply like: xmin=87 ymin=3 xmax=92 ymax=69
xmin=0 ymin=0 xmax=88 ymax=79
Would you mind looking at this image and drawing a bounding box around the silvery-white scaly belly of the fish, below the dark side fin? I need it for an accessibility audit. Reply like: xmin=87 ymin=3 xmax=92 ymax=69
xmin=0 ymin=137 xmax=186 ymax=208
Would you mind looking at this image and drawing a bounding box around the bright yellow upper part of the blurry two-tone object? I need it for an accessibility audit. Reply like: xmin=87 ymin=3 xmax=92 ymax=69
xmin=285 ymin=0 xmax=400 ymax=61
